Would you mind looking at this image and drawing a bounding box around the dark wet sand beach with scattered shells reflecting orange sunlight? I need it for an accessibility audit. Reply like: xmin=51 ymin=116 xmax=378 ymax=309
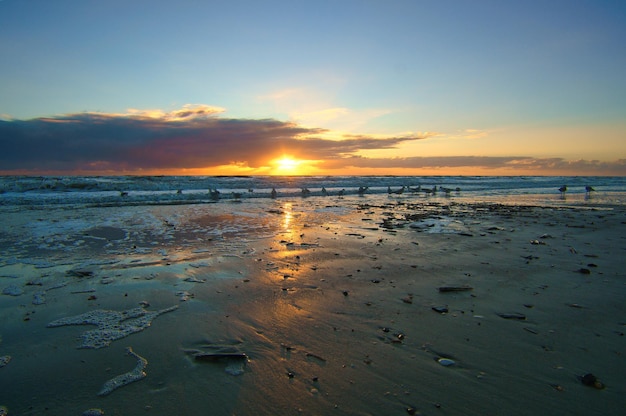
xmin=0 ymin=196 xmax=626 ymax=415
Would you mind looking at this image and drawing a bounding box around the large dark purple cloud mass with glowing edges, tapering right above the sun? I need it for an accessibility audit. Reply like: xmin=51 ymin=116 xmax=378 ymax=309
xmin=0 ymin=105 xmax=422 ymax=173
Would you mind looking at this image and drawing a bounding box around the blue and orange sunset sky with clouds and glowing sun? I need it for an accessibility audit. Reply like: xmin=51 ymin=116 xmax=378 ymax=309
xmin=0 ymin=0 xmax=626 ymax=176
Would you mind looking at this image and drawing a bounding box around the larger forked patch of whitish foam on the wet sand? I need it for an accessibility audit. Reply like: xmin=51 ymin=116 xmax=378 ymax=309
xmin=47 ymin=305 xmax=178 ymax=349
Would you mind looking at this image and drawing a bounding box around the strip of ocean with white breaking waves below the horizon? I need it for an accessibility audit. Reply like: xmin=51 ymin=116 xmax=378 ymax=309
xmin=0 ymin=176 xmax=626 ymax=209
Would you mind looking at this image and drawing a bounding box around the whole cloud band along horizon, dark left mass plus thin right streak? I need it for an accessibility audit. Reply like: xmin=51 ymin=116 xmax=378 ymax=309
xmin=0 ymin=106 xmax=626 ymax=176
